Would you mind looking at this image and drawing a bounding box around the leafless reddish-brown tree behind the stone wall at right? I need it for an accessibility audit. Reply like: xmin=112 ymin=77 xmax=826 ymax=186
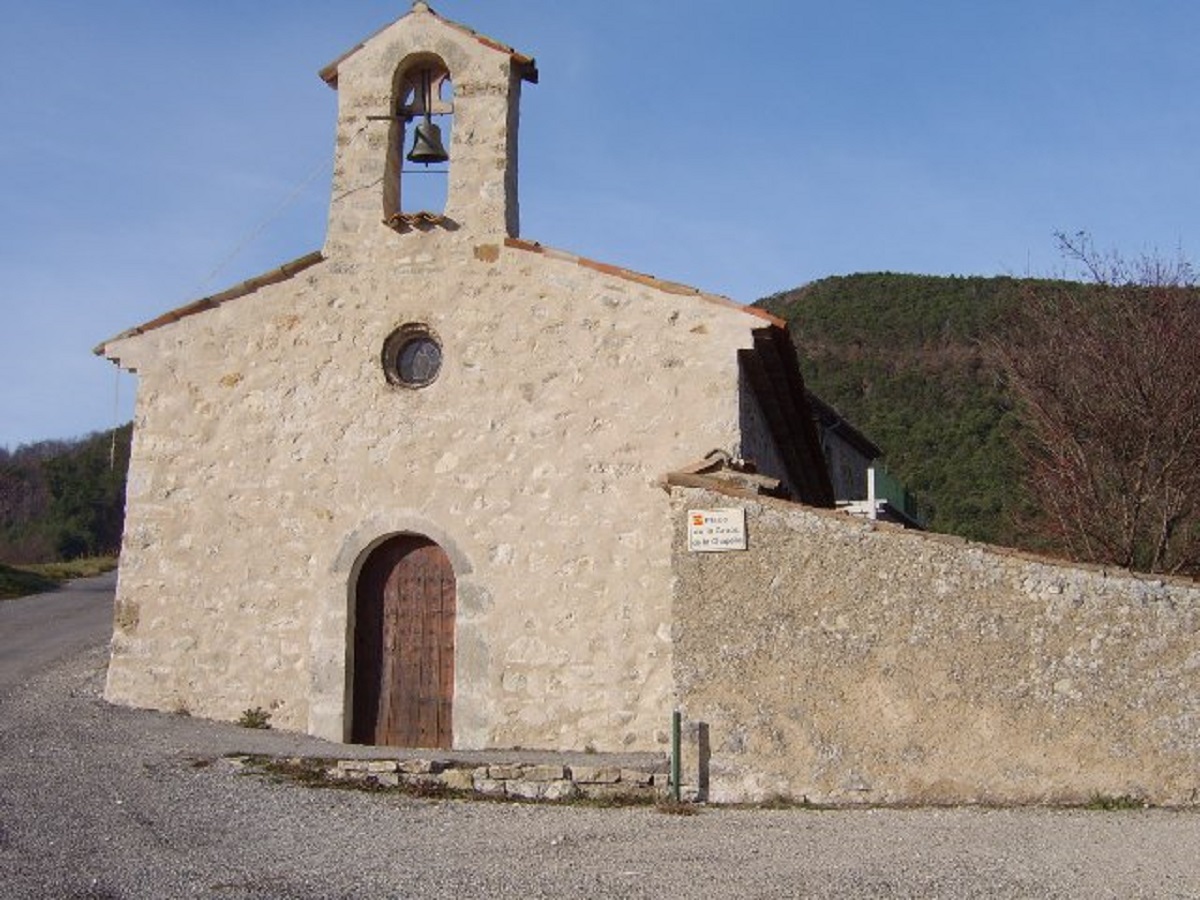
xmin=989 ymin=234 xmax=1200 ymax=575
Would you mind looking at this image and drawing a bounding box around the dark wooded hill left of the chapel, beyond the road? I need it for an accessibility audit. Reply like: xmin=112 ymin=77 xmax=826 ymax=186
xmin=0 ymin=425 xmax=132 ymax=564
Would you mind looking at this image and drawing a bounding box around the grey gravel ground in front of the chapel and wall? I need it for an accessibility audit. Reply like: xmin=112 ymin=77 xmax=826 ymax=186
xmin=0 ymin=647 xmax=1200 ymax=900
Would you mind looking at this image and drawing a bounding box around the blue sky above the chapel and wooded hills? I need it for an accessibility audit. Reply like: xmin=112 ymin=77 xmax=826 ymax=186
xmin=0 ymin=0 xmax=1200 ymax=448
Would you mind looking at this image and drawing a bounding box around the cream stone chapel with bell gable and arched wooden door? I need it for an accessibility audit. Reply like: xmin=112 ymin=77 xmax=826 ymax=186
xmin=97 ymin=2 xmax=834 ymax=750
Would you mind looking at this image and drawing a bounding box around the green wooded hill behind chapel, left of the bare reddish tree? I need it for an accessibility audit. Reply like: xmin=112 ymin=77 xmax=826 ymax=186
xmin=756 ymin=274 xmax=1051 ymax=548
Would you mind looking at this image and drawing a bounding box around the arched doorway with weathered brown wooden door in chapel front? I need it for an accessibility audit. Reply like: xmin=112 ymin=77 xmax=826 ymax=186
xmin=350 ymin=534 xmax=456 ymax=749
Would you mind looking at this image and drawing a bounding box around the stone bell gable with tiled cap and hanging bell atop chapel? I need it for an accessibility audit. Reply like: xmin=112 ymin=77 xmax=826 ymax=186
xmin=322 ymin=2 xmax=538 ymax=258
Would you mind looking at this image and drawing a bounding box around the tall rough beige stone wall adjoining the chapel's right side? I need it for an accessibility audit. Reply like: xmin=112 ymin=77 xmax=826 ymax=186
xmin=672 ymin=488 xmax=1200 ymax=806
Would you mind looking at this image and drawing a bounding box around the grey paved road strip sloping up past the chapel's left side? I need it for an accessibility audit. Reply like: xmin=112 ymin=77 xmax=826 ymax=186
xmin=0 ymin=572 xmax=116 ymax=694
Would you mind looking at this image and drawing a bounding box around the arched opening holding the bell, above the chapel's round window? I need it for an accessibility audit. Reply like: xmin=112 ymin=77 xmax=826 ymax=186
xmin=383 ymin=53 xmax=454 ymax=227
